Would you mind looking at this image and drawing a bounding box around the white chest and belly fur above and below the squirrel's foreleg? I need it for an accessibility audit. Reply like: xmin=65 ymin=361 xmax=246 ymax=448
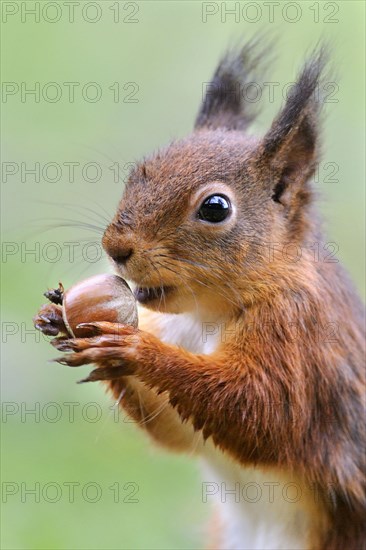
xmin=145 ymin=315 xmax=316 ymax=550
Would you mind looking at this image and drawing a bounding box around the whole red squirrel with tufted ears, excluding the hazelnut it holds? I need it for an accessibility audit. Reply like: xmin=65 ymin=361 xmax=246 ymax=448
xmin=35 ymin=44 xmax=366 ymax=550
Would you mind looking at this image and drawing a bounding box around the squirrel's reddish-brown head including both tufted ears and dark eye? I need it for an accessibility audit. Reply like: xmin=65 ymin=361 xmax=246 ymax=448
xmin=103 ymin=43 xmax=324 ymax=313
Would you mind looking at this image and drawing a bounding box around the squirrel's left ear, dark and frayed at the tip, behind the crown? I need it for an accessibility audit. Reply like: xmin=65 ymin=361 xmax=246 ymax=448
xmin=195 ymin=38 xmax=265 ymax=130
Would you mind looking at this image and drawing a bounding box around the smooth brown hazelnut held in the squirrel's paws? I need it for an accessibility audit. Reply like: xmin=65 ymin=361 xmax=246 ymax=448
xmin=62 ymin=274 xmax=138 ymax=338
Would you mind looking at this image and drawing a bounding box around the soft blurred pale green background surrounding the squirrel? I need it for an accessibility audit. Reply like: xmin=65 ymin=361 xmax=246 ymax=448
xmin=1 ymin=1 xmax=365 ymax=549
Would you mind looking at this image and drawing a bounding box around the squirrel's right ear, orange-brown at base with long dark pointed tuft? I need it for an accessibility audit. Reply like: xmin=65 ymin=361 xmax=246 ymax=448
xmin=258 ymin=48 xmax=325 ymax=208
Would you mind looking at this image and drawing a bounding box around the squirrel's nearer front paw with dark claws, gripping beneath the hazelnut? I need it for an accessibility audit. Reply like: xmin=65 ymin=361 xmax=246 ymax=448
xmin=51 ymin=322 xmax=144 ymax=382
